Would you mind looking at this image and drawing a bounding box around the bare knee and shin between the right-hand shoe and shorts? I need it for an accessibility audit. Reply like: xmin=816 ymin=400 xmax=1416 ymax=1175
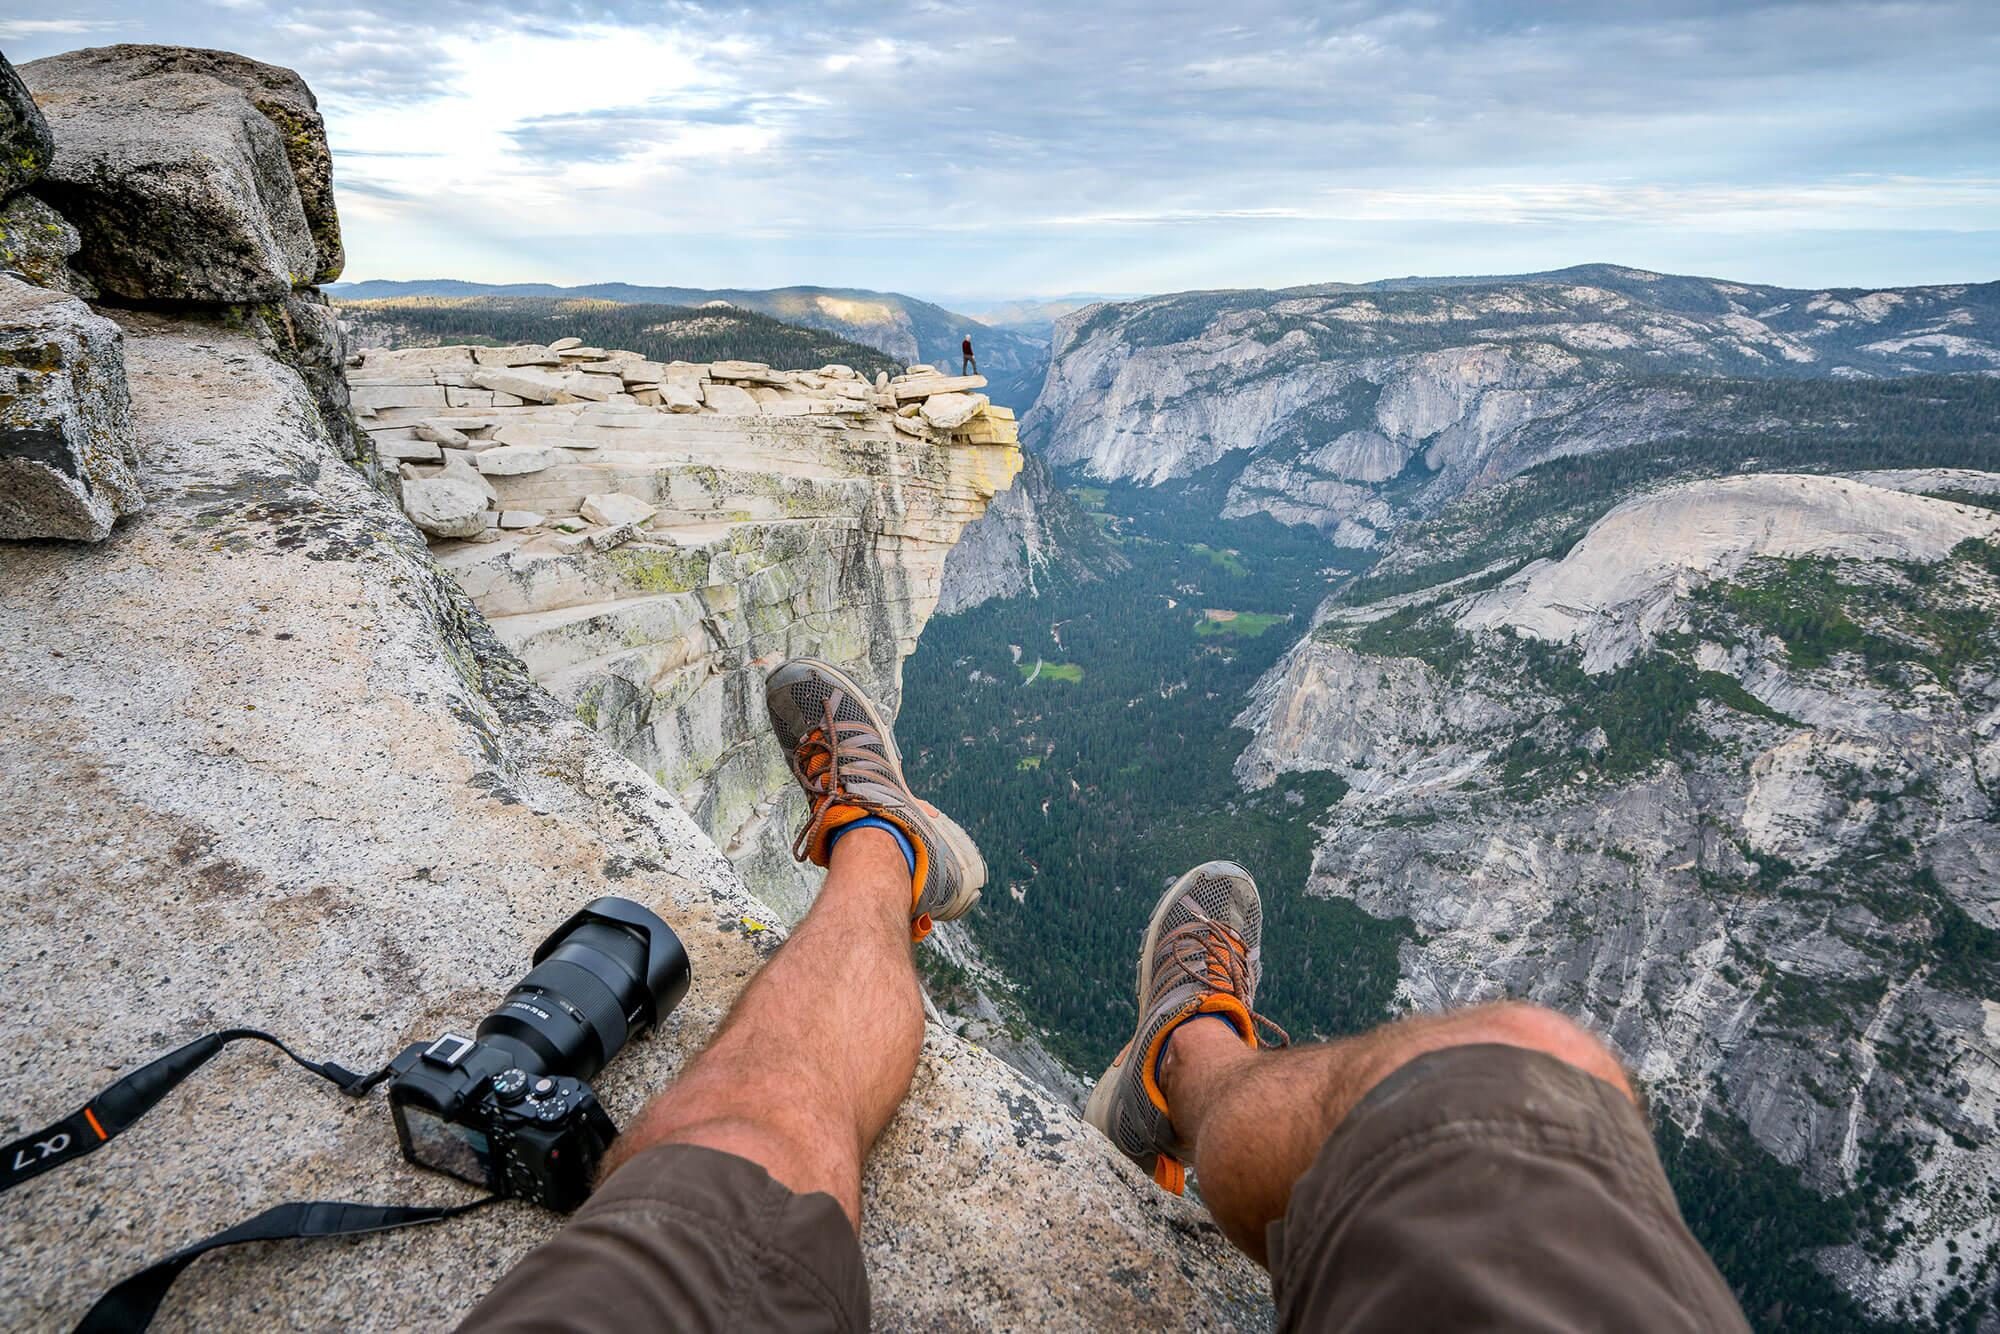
xmin=1160 ymin=1002 xmax=1638 ymax=1266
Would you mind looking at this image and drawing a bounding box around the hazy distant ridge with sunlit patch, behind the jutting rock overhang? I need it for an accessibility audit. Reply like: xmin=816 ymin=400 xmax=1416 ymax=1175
xmin=326 ymin=278 xmax=1048 ymax=412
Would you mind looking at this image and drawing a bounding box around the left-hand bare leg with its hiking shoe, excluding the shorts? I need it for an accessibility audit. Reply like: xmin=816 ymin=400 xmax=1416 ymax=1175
xmin=606 ymin=658 xmax=986 ymax=1230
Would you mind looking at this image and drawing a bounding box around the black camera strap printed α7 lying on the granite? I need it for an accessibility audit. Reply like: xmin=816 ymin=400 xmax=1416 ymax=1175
xmin=0 ymin=1028 xmax=500 ymax=1334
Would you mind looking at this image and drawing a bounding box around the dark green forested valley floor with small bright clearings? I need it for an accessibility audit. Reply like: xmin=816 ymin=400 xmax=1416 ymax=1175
xmin=898 ymin=480 xmax=1404 ymax=1072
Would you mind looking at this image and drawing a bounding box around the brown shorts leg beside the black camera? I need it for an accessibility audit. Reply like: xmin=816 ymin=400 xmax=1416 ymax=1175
xmin=460 ymin=1144 xmax=868 ymax=1334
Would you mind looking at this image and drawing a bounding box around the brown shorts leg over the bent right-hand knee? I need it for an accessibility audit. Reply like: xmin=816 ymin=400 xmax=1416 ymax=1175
xmin=1264 ymin=1044 xmax=1748 ymax=1332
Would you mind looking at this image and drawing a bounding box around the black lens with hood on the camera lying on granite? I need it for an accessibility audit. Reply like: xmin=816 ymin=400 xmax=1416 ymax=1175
xmin=480 ymin=898 xmax=688 ymax=1080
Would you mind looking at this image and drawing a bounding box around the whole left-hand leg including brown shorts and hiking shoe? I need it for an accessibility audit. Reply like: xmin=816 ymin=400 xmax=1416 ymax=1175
xmin=454 ymin=658 xmax=986 ymax=1334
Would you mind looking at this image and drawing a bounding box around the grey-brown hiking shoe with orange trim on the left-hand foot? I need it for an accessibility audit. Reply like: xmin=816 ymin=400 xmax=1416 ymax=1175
xmin=764 ymin=658 xmax=986 ymax=940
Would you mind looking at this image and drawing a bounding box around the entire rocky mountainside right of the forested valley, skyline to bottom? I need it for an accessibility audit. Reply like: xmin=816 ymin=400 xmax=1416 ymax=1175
xmin=1022 ymin=266 xmax=2000 ymax=1328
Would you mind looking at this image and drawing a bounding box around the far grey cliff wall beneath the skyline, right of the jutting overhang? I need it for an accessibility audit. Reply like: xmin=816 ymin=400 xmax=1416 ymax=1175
xmin=1022 ymin=266 xmax=2000 ymax=548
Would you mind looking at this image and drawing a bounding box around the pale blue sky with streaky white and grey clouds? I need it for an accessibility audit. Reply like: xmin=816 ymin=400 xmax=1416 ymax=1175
xmin=0 ymin=0 xmax=2000 ymax=300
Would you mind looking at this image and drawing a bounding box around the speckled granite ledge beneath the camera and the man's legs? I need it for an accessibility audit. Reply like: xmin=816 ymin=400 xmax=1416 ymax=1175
xmin=0 ymin=312 xmax=1270 ymax=1330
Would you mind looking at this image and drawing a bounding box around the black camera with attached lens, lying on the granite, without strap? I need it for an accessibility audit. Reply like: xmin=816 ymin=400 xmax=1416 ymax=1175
xmin=388 ymin=898 xmax=688 ymax=1212
